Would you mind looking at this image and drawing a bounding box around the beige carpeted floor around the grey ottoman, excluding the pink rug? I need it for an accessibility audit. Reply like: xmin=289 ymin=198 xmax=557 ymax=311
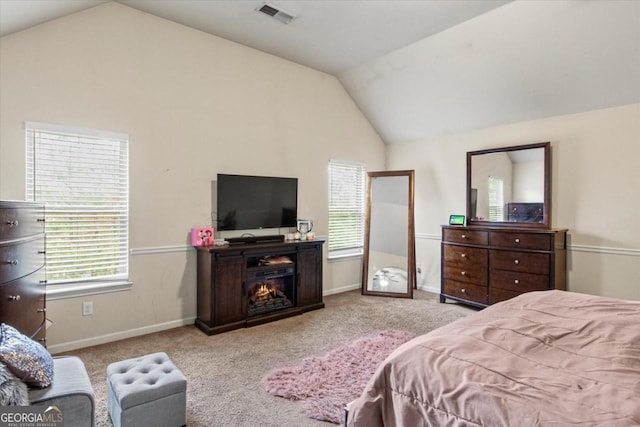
xmin=61 ymin=291 xmax=474 ymax=427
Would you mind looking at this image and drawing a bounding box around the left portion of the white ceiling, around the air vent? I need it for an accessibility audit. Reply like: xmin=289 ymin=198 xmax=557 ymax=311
xmin=0 ymin=0 xmax=508 ymax=75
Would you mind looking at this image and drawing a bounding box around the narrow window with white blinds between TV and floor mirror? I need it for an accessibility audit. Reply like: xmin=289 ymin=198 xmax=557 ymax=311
xmin=328 ymin=160 xmax=366 ymax=258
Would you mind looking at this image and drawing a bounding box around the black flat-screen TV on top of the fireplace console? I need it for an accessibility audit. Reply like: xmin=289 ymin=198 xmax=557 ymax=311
xmin=217 ymin=174 xmax=298 ymax=230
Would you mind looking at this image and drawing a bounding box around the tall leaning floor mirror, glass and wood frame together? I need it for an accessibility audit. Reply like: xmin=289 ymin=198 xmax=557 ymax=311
xmin=362 ymin=170 xmax=416 ymax=298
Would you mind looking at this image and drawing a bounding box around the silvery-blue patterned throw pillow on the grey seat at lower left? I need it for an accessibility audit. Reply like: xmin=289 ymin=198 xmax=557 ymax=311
xmin=0 ymin=323 xmax=53 ymax=387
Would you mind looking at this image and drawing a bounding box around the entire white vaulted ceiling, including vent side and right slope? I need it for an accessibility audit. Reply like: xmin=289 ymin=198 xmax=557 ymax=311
xmin=0 ymin=0 xmax=640 ymax=143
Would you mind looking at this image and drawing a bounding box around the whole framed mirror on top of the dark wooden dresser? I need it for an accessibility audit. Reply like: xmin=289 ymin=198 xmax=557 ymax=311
xmin=467 ymin=142 xmax=551 ymax=228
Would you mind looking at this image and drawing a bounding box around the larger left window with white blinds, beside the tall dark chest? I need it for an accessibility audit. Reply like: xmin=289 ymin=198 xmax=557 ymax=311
xmin=24 ymin=122 xmax=132 ymax=299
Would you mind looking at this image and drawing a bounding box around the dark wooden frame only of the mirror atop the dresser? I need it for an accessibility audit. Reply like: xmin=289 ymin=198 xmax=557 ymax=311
xmin=467 ymin=142 xmax=551 ymax=229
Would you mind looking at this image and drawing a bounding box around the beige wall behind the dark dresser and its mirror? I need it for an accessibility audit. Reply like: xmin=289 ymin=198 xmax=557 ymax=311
xmin=387 ymin=104 xmax=640 ymax=300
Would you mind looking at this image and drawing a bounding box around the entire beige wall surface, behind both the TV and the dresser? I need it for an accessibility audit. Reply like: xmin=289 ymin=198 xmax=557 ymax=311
xmin=0 ymin=3 xmax=640 ymax=351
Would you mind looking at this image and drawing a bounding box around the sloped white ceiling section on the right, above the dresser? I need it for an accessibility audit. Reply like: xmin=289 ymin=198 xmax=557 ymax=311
xmin=339 ymin=0 xmax=640 ymax=144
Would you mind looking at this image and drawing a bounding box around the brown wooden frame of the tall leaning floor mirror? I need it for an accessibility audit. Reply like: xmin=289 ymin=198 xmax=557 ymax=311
xmin=362 ymin=170 xmax=417 ymax=298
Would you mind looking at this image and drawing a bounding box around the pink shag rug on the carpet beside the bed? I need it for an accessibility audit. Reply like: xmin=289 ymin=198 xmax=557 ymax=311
xmin=263 ymin=330 xmax=415 ymax=424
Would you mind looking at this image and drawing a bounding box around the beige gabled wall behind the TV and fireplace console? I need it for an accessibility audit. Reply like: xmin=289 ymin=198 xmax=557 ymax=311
xmin=0 ymin=3 xmax=385 ymax=351
